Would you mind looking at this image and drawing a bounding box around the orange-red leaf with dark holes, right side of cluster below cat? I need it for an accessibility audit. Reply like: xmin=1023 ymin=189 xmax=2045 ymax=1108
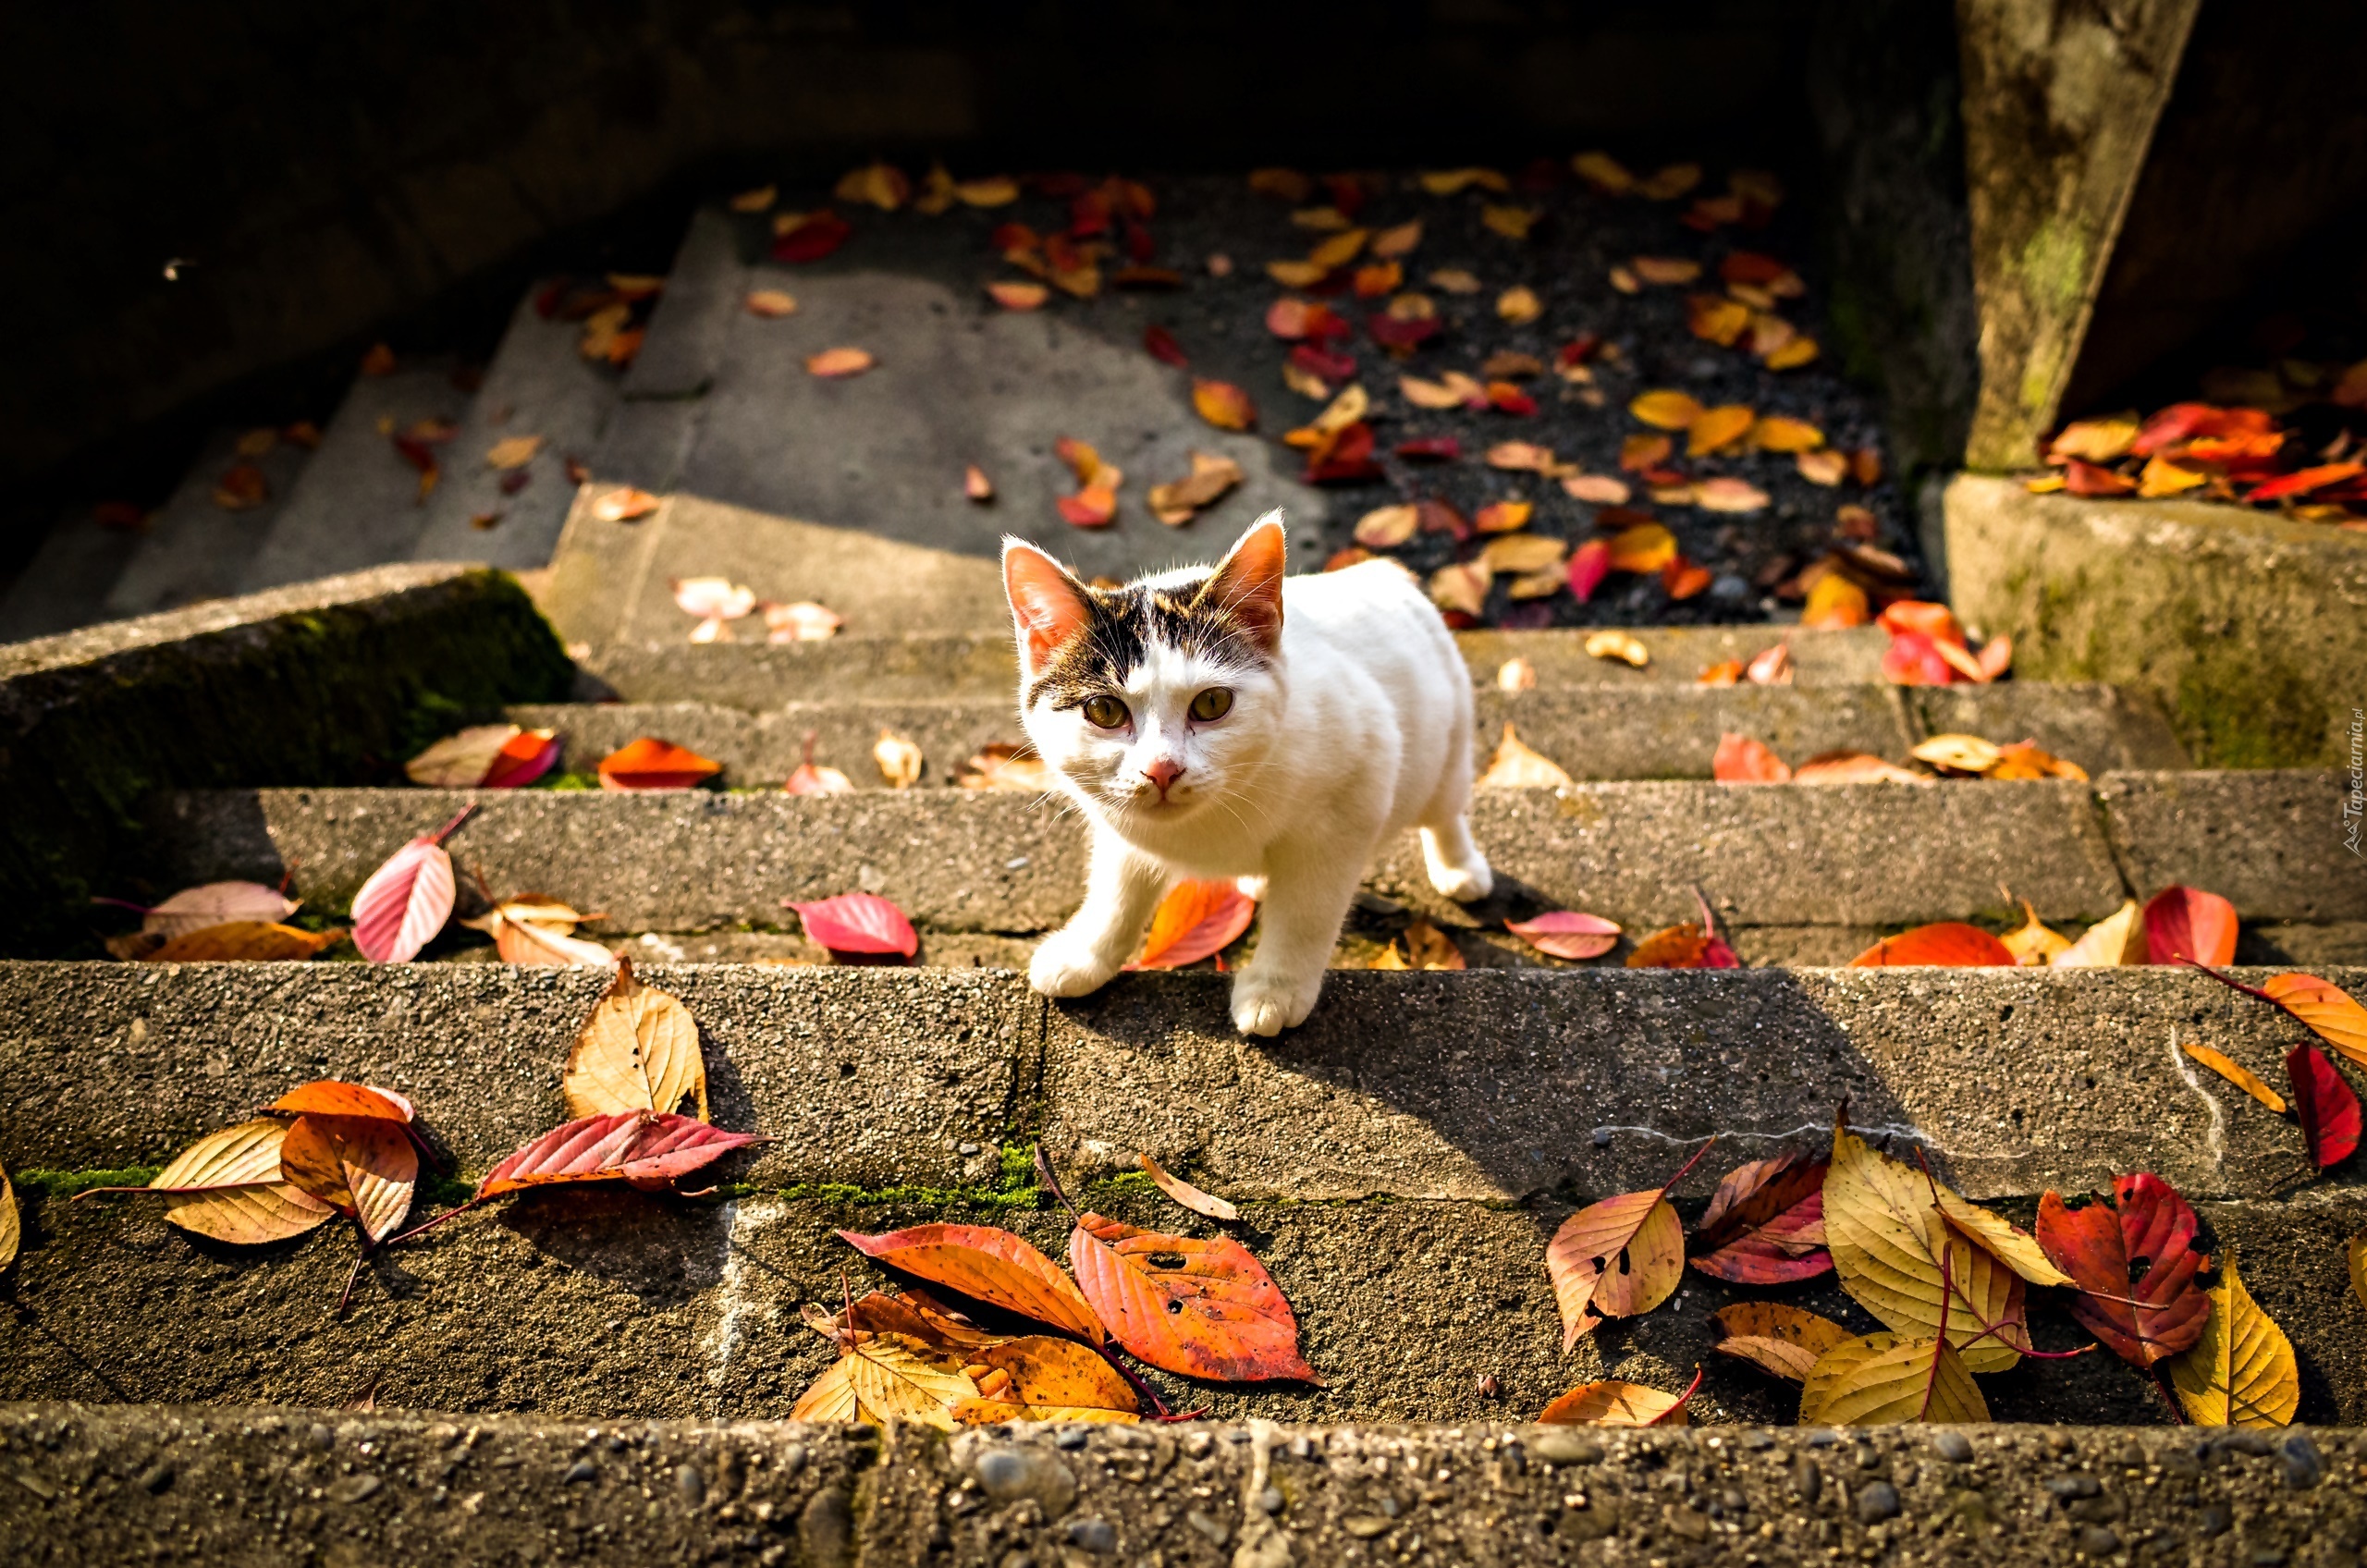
xmin=1068 ymin=1213 xmax=1320 ymax=1383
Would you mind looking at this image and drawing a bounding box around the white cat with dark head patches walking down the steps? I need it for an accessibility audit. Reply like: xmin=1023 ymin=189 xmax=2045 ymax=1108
xmin=1003 ymin=511 xmax=1493 ymax=1035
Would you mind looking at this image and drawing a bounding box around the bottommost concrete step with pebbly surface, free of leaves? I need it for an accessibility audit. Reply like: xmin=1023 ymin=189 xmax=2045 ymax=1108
xmin=14 ymin=1403 xmax=2367 ymax=1568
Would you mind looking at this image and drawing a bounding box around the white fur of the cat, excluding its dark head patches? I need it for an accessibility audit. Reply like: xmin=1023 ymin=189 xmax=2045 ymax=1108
xmin=1013 ymin=514 xmax=1493 ymax=1035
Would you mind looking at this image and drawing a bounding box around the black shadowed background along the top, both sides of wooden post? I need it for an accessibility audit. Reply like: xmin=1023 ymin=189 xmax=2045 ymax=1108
xmin=0 ymin=0 xmax=2367 ymax=582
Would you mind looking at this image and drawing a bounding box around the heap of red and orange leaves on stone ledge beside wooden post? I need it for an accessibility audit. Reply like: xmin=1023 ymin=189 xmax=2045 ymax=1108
xmin=2029 ymin=390 xmax=2367 ymax=528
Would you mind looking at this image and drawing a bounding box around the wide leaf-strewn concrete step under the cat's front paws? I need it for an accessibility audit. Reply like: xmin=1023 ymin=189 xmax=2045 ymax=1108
xmin=14 ymin=964 xmax=2367 ymax=1424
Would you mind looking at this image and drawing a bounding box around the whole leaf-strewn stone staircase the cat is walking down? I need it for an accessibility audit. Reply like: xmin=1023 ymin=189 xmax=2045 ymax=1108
xmin=0 ymin=200 xmax=2367 ymax=1568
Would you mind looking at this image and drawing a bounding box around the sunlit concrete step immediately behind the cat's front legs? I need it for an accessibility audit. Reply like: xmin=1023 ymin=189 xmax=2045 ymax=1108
xmin=149 ymin=772 xmax=2367 ymax=964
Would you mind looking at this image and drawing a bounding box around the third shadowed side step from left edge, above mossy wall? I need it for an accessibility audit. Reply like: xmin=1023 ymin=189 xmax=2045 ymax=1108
xmin=239 ymin=360 xmax=471 ymax=592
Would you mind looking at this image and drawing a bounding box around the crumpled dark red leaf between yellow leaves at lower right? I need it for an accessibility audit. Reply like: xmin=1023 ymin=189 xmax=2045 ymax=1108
xmin=2033 ymin=1172 xmax=2211 ymax=1366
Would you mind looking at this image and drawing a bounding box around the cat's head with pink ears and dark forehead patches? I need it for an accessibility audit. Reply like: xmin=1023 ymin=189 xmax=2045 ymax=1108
xmin=1003 ymin=517 xmax=1283 ymax=829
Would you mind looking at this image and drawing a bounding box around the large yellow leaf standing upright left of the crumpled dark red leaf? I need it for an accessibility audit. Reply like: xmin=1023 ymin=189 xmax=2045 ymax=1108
xmin=1825 ymin=1127 xmax=2021 ymax=1371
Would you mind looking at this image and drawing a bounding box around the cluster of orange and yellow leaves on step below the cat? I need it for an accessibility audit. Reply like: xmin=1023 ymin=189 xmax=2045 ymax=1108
xmin=791 ymin=1149 xmax=1323 ymax=1430
